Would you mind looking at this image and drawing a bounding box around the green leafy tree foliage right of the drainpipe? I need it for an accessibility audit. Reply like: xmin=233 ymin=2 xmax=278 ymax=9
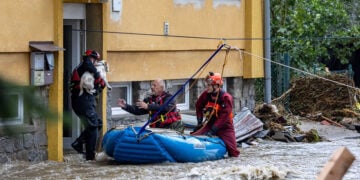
xmin=271 ymin=0 xmax=360 ymax=70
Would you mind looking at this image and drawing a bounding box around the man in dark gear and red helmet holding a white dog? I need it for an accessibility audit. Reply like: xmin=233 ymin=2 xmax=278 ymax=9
xmin=71 ymin=50 xmax=105 ymax=160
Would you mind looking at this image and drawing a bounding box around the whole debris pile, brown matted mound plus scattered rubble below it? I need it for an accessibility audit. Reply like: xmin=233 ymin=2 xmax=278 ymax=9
xmin=250 ymin=74 xmax=360 ymax=142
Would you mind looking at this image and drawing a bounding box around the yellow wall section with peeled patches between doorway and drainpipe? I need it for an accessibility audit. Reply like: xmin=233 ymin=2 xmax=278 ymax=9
xmin=104 ymin=0 xmax=263 ymax=82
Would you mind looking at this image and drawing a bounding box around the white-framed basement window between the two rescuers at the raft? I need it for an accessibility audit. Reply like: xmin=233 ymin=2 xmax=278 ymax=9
xmin=167 ymin=80 xmax=190 ymax=110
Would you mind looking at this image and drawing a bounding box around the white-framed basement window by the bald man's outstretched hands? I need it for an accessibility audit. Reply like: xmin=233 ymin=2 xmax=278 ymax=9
xmin=111 ymin=83 xmax=132 ymax=116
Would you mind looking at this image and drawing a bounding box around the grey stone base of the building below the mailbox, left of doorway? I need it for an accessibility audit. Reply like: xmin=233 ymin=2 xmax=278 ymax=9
xmin=0 ymin=87 xmax=48 ymax=163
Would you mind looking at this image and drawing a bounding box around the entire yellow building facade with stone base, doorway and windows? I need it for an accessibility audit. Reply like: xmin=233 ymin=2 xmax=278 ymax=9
xmin=0 ymin=0 xmax=264 ymax=162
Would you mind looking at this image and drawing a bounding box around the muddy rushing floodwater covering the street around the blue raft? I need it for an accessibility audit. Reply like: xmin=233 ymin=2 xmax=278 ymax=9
xmin=0 ymin=122 xmax=360 ymax=180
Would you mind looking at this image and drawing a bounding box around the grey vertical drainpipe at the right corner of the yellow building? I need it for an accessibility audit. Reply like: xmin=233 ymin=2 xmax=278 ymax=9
xmin=264 ymin=0 xmax=271 ymax=104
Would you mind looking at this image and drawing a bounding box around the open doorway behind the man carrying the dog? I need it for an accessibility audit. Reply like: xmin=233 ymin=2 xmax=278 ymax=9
xmin=63 ymin=3 xmax=103 ymax=150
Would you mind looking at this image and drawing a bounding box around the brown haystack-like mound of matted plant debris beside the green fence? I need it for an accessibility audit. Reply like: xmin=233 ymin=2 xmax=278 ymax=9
xmin=289 ymin=74 xmax=359 ymax=117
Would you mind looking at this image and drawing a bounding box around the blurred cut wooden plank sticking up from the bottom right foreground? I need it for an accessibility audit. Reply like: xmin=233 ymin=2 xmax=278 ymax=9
xmin=317 ymin=147 xmax=355 ymax=180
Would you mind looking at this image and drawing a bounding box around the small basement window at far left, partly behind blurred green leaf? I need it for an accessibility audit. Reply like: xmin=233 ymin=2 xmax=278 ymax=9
xmin=0 ymin=92 xmax=24 ymax=125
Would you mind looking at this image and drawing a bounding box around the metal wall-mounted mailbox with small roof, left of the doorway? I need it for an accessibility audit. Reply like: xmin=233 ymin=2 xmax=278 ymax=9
xmin=30 ymin=41 xmax=64 ymax=86
